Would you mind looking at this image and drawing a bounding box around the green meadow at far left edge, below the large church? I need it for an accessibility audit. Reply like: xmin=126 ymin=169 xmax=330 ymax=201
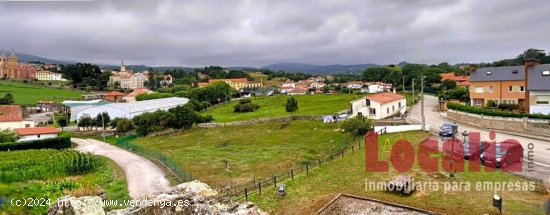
xmin=0 ymin=81 xmax=82 ymax=105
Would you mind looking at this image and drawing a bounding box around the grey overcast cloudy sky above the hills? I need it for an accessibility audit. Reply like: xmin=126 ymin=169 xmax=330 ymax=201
xmin=0 ymin=0 xmax=550 ymax=66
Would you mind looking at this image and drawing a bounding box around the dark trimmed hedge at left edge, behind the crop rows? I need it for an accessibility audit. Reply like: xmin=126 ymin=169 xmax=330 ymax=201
xmin=0 ymin=135 xmax=71 ymax=151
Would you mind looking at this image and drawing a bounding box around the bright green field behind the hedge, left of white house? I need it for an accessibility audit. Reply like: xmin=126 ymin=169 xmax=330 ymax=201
xmin=205 ymin=94 xmax=363 ymax=122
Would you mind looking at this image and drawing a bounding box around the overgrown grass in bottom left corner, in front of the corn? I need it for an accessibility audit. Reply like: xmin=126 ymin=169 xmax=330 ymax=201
xmin=0 ymin=155 xmax=130 ymax=215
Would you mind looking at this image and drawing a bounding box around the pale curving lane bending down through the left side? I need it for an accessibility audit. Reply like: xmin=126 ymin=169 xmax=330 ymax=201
xmin=71 ymin=138 xmax=170 ymax=199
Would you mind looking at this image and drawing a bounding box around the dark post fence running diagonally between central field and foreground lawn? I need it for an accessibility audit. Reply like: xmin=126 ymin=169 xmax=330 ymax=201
xmin=226 ymin=129 xmax=402 ymax=201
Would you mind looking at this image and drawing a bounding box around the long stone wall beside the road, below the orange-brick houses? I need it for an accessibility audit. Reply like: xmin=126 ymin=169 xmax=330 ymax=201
xmin=447 ymin=110 xmax=550 ymax=137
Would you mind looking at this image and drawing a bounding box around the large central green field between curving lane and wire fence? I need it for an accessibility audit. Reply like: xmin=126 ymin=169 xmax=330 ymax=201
xmin=134 ymin=121 xmax=358 ymax=186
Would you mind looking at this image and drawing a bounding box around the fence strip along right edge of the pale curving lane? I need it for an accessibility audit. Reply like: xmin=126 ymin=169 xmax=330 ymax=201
xmin=116 ymin=135 xmax=193 ymax=182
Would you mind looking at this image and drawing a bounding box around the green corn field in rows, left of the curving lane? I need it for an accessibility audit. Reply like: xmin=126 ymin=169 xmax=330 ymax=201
xmin=0 ymin=149 xmax=99 ymax=183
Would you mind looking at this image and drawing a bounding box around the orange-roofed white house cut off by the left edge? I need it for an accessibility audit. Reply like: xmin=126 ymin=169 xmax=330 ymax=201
xmin=0 ymin=105 xmax=34 ymax=130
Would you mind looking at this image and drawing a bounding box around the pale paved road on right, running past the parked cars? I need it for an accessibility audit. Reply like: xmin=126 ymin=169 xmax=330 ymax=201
xmin=409 ymin=95 xmax=550 ymax=181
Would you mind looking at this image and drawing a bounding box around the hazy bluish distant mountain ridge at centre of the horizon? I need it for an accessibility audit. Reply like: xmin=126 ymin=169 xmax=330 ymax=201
xmin=262 ymin=63 xmax=380 ymax=75
